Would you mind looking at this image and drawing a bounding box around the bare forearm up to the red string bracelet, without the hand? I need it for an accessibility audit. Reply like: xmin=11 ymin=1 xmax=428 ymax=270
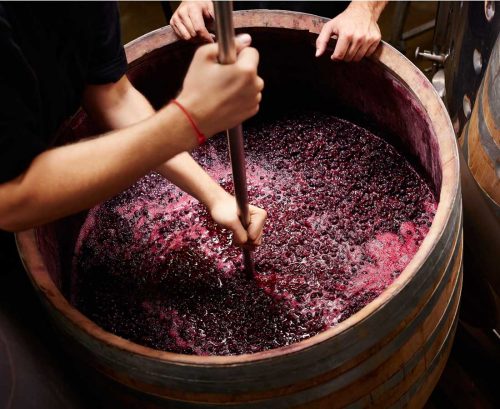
xmin=0 ymin=103 xmax=197 ymax=231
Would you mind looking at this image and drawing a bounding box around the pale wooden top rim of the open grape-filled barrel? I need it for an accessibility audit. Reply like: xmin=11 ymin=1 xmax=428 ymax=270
xmin=16 ymin=10 xmax=460 ymax=367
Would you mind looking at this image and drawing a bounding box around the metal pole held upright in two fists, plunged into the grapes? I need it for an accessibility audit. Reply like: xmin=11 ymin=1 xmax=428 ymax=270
xmin=214 ymin=1 xmax=255 ymax=277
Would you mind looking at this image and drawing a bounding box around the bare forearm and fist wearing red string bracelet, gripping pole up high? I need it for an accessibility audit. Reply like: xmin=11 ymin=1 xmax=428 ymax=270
xmin=0 ymin=41 xmax=263 ymax=236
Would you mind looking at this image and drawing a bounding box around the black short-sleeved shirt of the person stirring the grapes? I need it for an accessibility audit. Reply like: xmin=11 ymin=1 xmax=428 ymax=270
xmin=0 ymin=2 xmax=127 ymax=183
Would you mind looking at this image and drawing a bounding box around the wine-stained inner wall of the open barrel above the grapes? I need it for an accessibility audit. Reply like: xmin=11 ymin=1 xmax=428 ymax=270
xmin=36 ymin=28 xmax=442 ymax=334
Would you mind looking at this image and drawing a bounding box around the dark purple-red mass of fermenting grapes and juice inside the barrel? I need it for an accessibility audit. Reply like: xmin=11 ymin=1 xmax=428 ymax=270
xmin=72 ymin=113 xmax=437 ymax=355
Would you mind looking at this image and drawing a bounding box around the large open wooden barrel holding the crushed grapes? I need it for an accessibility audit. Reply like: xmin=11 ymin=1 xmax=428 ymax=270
xmin=17 ymin=11 xmax=462 ymax=409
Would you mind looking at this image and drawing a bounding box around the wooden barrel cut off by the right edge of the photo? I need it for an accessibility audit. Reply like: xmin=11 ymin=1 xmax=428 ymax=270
xmin=459 ymin=35 xmax=500 ymax=329
